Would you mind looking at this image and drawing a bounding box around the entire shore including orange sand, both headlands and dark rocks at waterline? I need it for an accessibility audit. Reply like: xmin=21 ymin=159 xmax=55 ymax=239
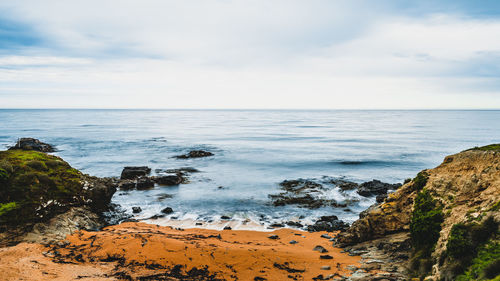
xmin=0 ymin=138 xmax=500 ymax=281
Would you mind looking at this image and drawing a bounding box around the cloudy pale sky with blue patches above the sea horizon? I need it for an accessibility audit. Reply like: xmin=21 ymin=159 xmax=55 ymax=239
xmin=0 ymin=0 xmax=500 ymax=109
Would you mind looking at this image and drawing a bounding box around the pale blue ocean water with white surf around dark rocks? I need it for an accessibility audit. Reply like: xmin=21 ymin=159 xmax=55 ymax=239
xmin=0 ymin=109 xmax=500 ymax=229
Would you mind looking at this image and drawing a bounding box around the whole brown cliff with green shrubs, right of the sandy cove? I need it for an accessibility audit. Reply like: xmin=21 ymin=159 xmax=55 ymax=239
xmin=337 ymin=145 xmax=500 ymax=280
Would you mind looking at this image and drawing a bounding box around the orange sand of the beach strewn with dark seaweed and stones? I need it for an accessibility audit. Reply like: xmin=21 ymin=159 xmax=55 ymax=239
xmin=0 ymin=223 xmax=360 ymax=280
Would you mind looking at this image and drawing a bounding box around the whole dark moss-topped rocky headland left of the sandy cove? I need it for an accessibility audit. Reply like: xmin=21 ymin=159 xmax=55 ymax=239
xmin=0 ymin=142 xmax=116 ymax=244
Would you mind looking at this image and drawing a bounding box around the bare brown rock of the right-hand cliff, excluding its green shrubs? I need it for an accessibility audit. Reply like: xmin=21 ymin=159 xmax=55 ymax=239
xmin=338 ymin=149 xmax=500 ymax=280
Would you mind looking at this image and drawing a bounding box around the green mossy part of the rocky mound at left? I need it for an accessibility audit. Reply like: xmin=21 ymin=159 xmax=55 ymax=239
xmin=0 ymin=150 xmax=84 ymax=223
